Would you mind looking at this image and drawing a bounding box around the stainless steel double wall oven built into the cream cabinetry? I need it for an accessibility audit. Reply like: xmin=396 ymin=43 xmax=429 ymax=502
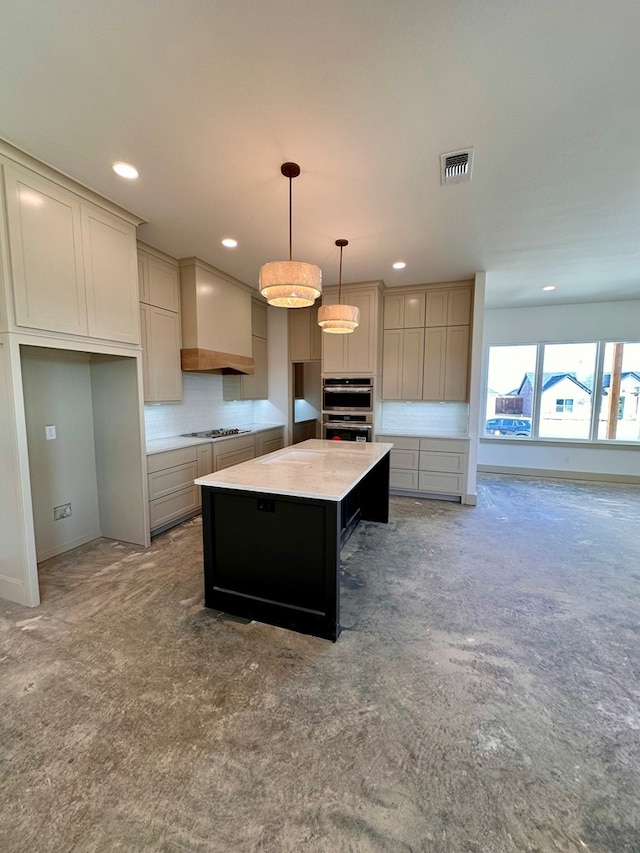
xmin=322 ymin=377 xmax=373 ymax=441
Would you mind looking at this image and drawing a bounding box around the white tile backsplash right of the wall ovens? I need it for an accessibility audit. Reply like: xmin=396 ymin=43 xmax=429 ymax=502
xmin=376 ymin=403 xmax=469 ymax=436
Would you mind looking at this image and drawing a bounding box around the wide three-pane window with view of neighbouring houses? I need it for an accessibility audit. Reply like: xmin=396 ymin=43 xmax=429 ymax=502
xmin=484 ymin=341 xmax=640 ymax=441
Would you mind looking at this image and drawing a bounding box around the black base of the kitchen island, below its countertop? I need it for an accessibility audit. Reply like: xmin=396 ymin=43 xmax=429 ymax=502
xmin=202 ymin=446 xmax=389 ymax=642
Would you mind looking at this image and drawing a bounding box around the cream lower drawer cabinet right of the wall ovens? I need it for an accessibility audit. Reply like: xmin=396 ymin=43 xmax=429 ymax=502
xmin=377 ymin=435 xmax=469 ymax=501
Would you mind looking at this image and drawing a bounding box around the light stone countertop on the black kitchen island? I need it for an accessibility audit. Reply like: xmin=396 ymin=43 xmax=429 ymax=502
xmin=195 ymin=438 xmax=393 ymax=501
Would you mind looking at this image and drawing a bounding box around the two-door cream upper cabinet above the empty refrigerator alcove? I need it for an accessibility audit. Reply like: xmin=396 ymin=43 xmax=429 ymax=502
xmin=3 ymin=161 xmax=140 ymax=343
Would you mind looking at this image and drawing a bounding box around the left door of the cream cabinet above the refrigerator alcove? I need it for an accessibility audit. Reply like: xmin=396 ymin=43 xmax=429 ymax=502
xmin=4 ymin=166 xmax=87 ymax=335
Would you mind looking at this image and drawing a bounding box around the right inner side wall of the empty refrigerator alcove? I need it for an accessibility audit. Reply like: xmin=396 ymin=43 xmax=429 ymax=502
xmin=91 ymin=355 xmax=149 ymax=545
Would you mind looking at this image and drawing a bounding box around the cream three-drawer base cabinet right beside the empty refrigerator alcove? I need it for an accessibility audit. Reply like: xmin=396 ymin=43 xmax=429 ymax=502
xmin=147 ymin=445 xmax=200 ymax=535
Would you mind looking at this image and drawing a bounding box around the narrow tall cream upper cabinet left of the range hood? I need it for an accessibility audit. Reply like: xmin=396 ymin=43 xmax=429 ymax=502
xmin=138 ymin=243 xmax=182 ymax=403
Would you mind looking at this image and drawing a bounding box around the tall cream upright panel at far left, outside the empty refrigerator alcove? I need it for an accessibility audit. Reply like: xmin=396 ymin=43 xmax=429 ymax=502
xmin=0 ymin=340 xmax=40 ymax=607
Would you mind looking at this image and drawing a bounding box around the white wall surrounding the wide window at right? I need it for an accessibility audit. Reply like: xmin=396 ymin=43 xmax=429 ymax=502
xmin=478 ymin=300 xmax=640 ymax=479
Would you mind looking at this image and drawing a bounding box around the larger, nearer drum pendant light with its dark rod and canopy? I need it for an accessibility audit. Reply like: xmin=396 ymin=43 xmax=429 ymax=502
xmin=259 ymin=163 xmax=322 ymax=308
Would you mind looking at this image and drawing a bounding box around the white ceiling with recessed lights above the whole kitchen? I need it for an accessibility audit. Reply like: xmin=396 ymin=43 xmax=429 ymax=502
xmin=0 ymin=0 xmax=640 ymax=307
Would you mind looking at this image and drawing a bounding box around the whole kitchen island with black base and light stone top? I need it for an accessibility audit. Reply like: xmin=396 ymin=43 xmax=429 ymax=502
xmin=195 ymin=439 xmax=393 ymax=641
